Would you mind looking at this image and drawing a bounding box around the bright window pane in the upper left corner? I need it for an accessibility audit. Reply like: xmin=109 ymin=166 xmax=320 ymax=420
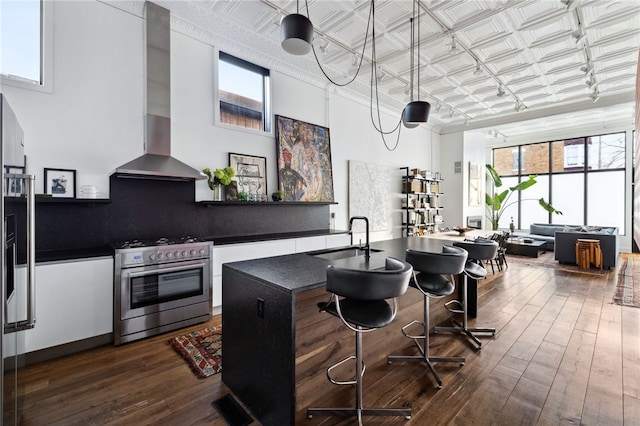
xmin=0 ymin=0 xmax=41 ymax=83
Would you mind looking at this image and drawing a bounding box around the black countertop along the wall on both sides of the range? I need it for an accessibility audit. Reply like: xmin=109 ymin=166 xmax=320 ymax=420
xmin=35 ymin=229 xmax=349 ymax=263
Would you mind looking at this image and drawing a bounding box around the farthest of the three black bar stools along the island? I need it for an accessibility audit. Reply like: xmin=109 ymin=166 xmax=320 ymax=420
xmin=434 ymin=240 xmax=498 ymax=349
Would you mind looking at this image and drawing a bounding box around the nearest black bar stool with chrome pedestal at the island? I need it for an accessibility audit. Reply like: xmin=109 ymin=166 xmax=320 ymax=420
xmin=307 ymin=257 xmax=413 ymax=424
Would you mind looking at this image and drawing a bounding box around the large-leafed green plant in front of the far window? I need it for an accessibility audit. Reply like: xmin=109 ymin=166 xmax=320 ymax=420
xmin=485 ymin=164 xmax=562 ymax=230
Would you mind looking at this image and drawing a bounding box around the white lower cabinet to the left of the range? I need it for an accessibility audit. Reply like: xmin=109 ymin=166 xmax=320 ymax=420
xmin=25 ymin=257 xmax=113 ymax=352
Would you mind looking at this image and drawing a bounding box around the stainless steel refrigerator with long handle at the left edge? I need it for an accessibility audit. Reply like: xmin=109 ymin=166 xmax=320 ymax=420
xmin=0 ymin=93 xmax=35 ymax=426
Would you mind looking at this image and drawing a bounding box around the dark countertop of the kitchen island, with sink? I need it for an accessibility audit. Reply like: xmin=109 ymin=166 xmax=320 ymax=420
xmin=223 ymin=237 xmax=451 ymax=292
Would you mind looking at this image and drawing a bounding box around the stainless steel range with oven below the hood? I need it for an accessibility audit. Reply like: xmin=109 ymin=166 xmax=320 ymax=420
xmin=113 ymin=238 xmax=213 ymax=345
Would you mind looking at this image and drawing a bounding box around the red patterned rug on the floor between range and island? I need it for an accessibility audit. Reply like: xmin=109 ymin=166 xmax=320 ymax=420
xmin=169 ymin=326 xmax=222 ymax=379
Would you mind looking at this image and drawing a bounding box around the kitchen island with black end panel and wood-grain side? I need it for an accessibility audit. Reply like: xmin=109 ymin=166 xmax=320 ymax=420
xmin=222 ymin=237 xmax=458 ymax=425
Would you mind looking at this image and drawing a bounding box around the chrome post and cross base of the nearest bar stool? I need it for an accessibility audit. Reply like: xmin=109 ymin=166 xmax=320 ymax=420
xmin=307 ymin=327 xmax=411 ymax=425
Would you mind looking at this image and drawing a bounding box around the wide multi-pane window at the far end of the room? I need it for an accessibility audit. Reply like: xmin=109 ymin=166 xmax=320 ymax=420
xmin=493 ymin=133 xmax=626 ymax=234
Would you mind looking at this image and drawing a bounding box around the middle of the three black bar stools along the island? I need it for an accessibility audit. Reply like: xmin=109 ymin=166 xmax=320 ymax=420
xmin=387 ymin=246 xmax=467 ymax=388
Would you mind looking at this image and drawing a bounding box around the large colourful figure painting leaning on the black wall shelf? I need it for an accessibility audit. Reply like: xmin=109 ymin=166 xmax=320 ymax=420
xmin=276 ymin=115 xmax=334 ymax=202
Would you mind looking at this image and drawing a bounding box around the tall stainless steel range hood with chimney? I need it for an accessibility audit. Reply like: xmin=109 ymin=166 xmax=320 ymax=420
xmin=114 ymin=2 xmax=206 ymax=180
